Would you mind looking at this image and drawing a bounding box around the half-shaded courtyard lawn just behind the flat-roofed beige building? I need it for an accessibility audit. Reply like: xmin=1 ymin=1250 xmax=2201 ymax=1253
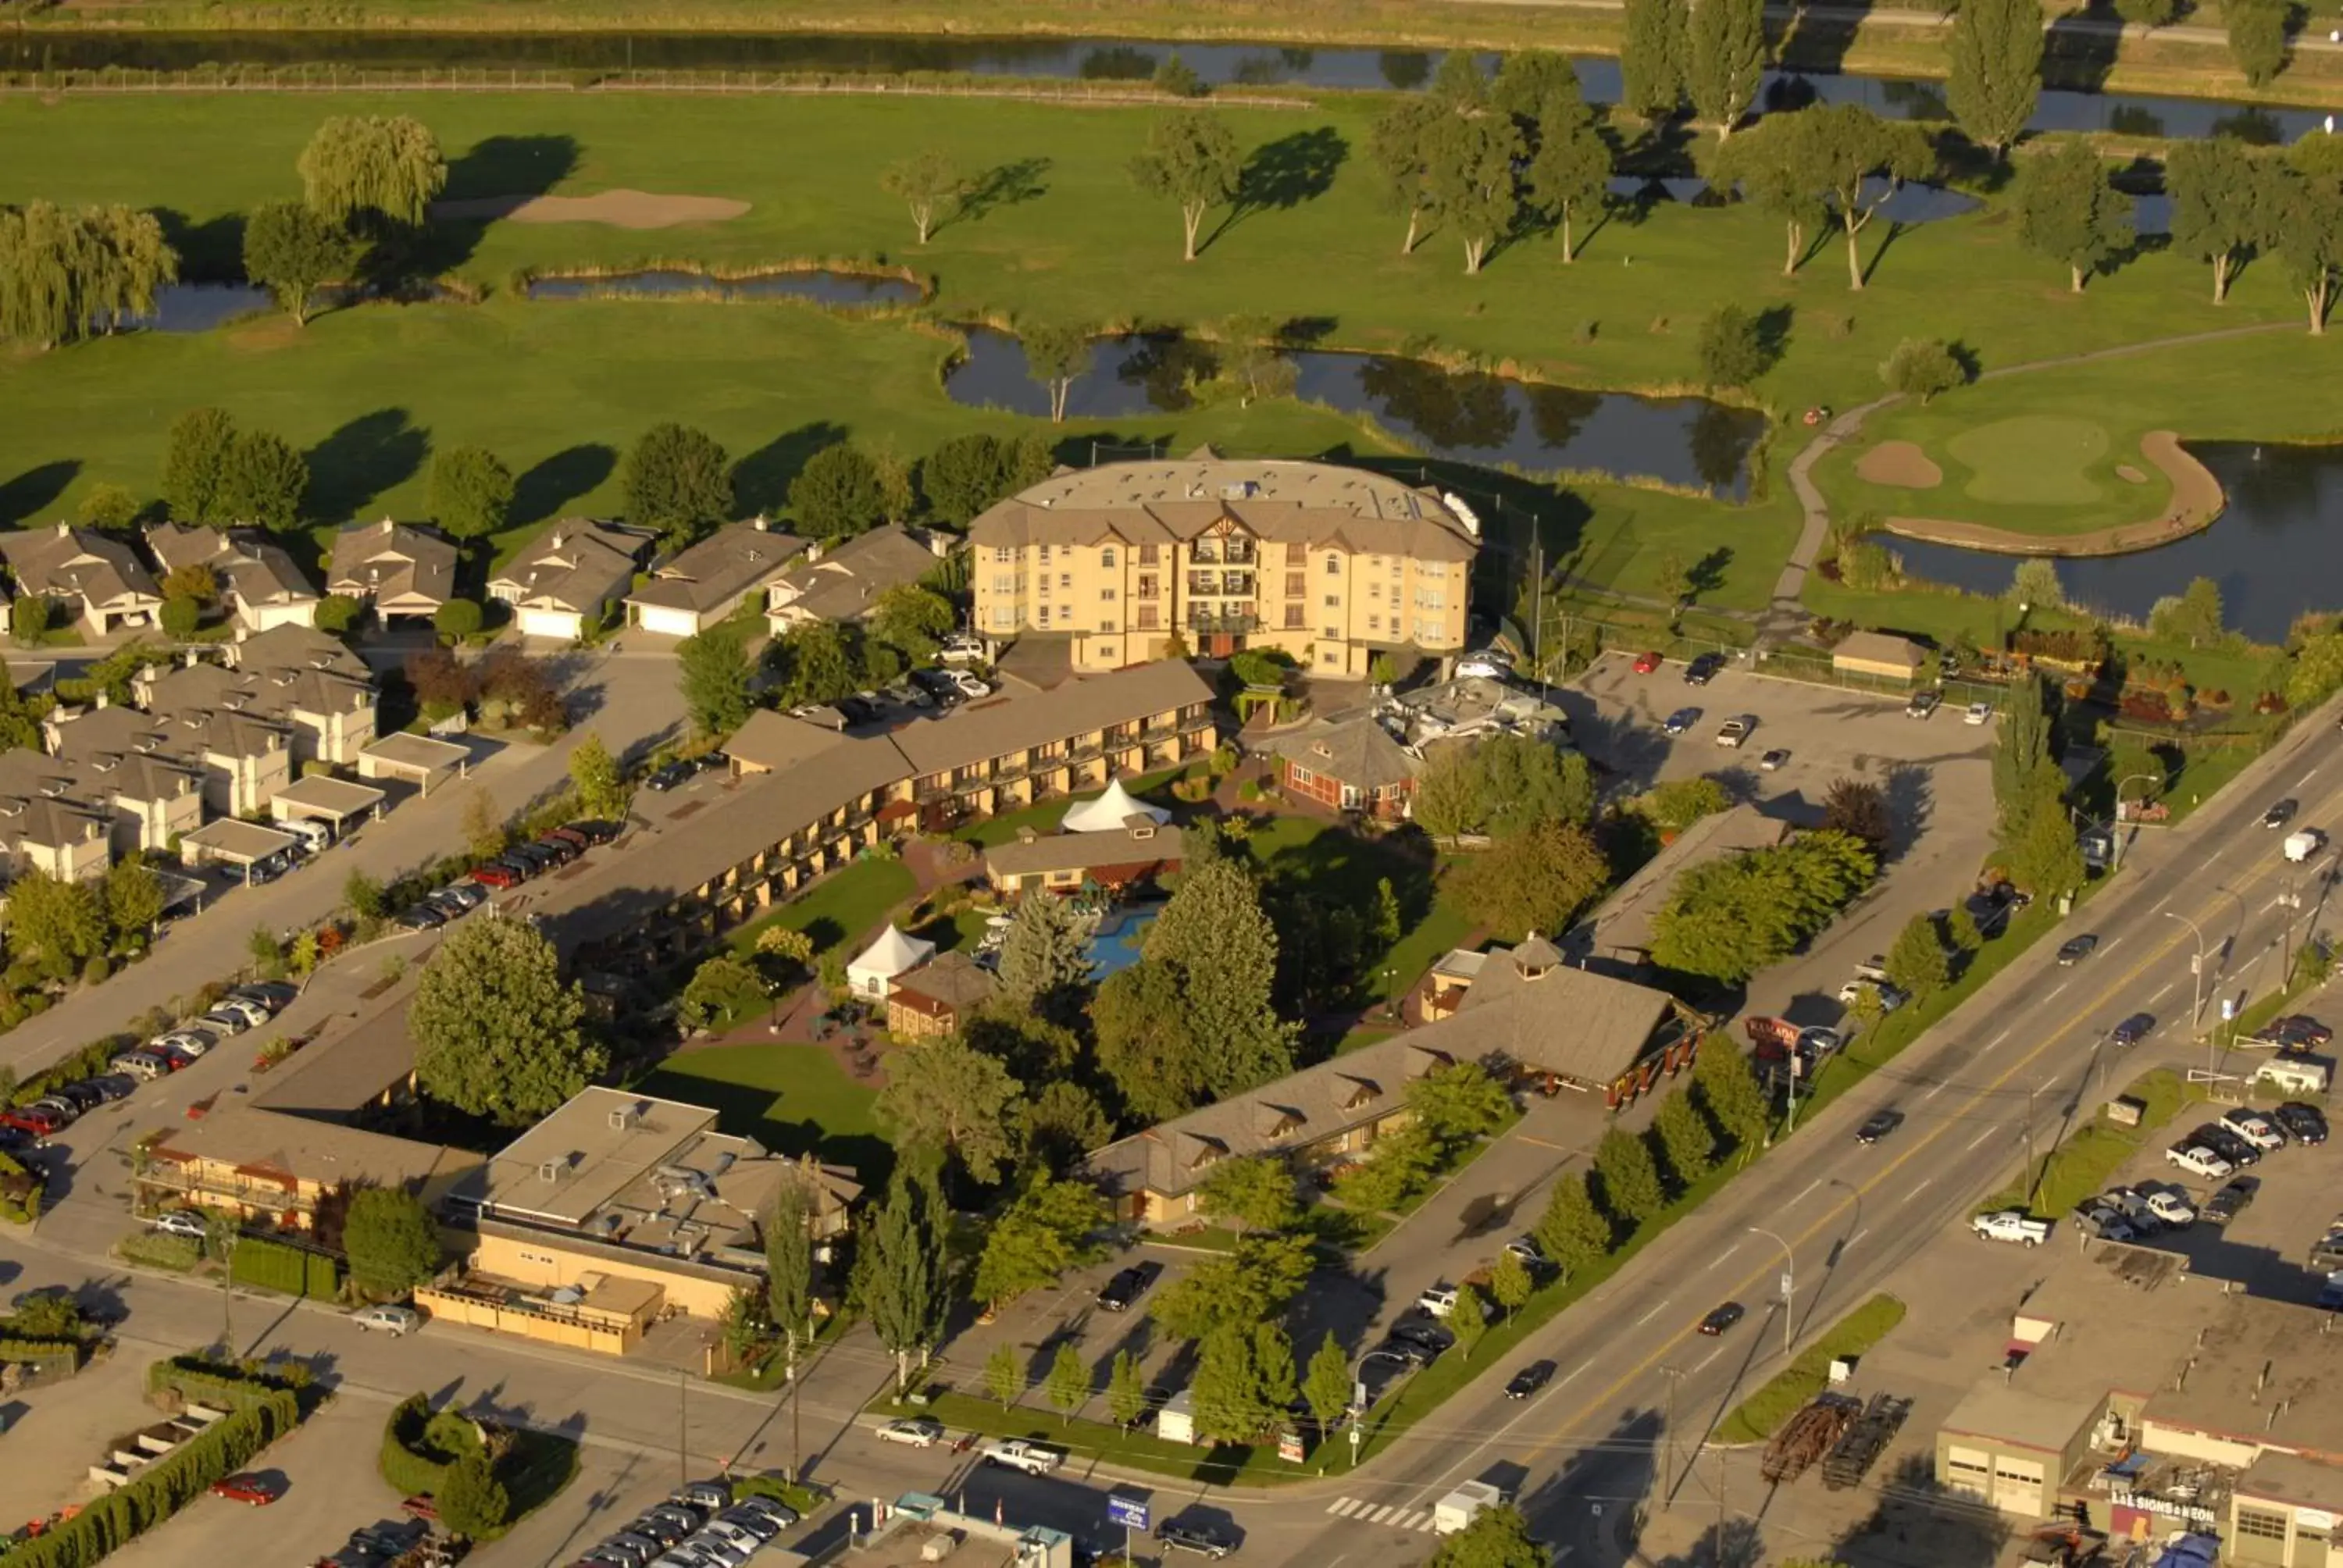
xmin=633 ymin=1046 xmax=895 ymax=1186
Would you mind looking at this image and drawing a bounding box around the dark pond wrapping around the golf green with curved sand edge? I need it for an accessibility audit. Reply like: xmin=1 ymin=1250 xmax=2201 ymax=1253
xmin=1881 ymin=440 xmax=2343 ymax=642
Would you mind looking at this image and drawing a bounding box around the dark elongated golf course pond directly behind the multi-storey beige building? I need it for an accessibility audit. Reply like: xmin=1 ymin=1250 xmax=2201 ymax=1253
xmin=944 ymin=328 xmax=1764 ymax=501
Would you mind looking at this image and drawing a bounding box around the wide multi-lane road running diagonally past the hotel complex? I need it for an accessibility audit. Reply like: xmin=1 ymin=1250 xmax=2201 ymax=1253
xmin=1235 ymin=703 xmax=2343 ymax=1568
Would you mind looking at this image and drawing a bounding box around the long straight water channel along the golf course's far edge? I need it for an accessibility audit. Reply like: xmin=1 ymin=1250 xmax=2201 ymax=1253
xmin=0 ymin=28 xmax=2324 ymax=143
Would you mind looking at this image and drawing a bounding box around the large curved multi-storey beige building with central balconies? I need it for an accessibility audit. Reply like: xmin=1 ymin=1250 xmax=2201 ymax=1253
xmin=968 ymin=447 xmax=1481 ymax=677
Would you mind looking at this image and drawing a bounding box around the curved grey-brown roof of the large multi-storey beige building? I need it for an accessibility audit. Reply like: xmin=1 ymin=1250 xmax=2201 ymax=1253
xmin=968 ymin=447 xmax=1481 ymax=560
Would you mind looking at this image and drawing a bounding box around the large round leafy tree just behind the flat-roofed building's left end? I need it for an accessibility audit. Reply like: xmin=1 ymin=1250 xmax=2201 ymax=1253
xmin=408 ymin=919 xmax=609 ymax=1128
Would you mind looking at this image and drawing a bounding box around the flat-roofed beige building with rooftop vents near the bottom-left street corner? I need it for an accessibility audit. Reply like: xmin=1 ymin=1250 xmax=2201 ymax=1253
xmin=443 ymin=1088 xmax=862 ymax=1349
